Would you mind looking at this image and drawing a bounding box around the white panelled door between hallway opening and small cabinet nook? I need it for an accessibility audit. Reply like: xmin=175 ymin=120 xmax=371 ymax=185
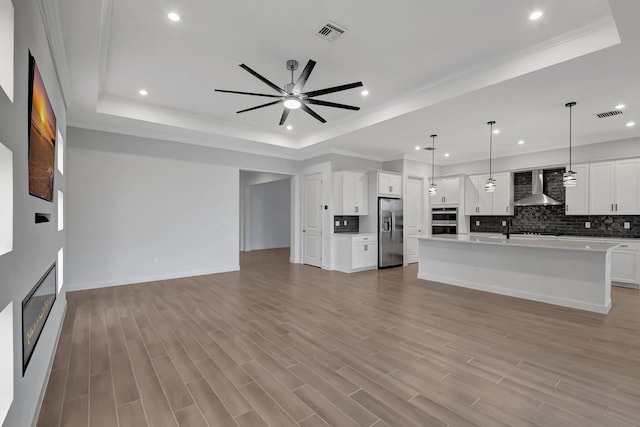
xmin=302 ymin=173 xmax=322 ymax=267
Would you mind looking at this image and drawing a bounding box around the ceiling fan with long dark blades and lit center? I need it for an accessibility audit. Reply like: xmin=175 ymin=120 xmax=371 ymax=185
xmin=216 ymin=59 xmax=362 ymax=126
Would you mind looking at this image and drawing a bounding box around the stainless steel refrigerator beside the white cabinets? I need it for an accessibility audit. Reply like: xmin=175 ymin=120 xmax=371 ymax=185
xmin=378 ymin=197 xmax=403 ymax=268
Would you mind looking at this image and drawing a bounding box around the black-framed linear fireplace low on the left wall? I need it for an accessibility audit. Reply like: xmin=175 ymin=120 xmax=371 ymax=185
xmin=22 ymin=263 xmax=56 ymax=375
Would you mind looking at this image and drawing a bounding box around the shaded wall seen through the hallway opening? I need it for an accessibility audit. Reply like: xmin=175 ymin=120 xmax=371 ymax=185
xmin=247 ymin=179 xmax=291 ymax=250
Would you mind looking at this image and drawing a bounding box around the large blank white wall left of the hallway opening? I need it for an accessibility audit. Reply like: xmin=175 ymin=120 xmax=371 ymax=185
xmin=66 ymin=129 xmax=245 ymax=289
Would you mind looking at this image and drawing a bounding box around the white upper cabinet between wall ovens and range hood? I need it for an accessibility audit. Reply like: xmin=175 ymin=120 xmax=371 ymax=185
xmin=464 ymin=172 xmax=513 ymax=216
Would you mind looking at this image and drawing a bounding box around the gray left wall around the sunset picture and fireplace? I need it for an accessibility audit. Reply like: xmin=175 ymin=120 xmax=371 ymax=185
xmin=0 ymin=0 xmax=66 ymax=427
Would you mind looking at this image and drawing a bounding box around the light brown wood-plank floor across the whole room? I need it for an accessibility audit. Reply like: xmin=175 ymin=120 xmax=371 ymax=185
xmin=38 ymin=250 xmax=640 ymax=427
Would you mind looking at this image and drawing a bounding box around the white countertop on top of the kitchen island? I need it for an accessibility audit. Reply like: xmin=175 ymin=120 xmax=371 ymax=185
xmin=418 ymin=233 xmax=619 ymax=252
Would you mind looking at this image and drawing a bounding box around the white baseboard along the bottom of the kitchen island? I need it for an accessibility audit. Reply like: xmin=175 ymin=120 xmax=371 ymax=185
xmin=418 ymin=273 xmax=611 ymax=314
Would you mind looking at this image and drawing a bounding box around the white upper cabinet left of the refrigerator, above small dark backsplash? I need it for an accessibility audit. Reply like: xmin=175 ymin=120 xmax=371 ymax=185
xmin=333 ymin=171 xmax=369 ymax=215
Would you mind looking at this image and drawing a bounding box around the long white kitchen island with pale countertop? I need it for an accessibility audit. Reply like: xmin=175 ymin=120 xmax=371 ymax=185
xmin=418 ymin=234 xmax=617 ymax=313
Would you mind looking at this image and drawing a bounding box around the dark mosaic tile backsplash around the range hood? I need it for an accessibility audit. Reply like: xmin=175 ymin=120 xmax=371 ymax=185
xmin=469 ymin=168 xmax=640 ymax=238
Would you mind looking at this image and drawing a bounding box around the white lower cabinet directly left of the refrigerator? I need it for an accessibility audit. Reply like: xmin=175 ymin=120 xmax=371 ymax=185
xmin=334 ymin=233 xmax=378 ymax=273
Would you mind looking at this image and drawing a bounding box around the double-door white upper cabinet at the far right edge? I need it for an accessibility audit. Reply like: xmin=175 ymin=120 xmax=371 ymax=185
xmin=589 ymin=159 xmax=640 ymax=215
